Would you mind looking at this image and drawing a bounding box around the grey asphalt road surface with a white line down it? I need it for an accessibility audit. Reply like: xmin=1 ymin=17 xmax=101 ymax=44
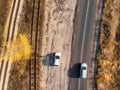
xmin=69 ymin=0 xmax=96 ymax=90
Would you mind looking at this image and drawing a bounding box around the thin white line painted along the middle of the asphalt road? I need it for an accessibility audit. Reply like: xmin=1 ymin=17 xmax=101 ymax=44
xmin=78 ymin=0 xmax=90 ymax=90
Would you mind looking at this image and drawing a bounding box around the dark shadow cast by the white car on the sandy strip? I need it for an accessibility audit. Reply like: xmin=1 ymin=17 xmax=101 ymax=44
xmin=42 ymin=53 xmax=55 ymax=66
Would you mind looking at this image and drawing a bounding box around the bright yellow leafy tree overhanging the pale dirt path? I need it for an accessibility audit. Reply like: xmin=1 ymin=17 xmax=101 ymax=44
xmin=4 ymin=34 xmax=32 ymax=62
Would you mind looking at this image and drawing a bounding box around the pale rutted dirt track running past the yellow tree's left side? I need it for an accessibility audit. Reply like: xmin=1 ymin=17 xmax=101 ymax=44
xmin=0 ymin=0 xmax=23 ymax=90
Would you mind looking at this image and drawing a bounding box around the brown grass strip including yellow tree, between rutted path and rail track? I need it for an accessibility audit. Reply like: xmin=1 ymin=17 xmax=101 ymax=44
xmin=8 ymin=0 xmax=32 ymax=90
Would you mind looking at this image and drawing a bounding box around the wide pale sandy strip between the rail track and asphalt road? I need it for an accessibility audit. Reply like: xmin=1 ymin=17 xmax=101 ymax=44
xmin=40 ymin=0 xmax=77 ymax=90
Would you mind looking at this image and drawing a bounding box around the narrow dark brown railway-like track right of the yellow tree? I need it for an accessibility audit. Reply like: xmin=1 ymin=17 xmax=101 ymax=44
xmin=29 ymin=0 xmax=40 ymax=90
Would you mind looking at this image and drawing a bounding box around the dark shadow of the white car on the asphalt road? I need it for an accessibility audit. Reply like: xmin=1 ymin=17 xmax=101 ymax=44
xmin=67 ymin=63 xmax=81 ymax=78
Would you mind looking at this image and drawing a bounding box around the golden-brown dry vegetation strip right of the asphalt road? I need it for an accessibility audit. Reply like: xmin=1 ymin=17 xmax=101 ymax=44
xmin=96 ymin=0 xmax=120 ymax=90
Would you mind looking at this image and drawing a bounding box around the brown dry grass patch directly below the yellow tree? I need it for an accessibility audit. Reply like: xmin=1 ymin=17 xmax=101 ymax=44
xmin=8 ymin=60 xmax=28 ymax=90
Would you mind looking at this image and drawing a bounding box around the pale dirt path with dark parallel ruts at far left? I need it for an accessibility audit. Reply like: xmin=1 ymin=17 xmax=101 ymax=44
xmin=0 ymin=0 xmax=23 ymax=90
